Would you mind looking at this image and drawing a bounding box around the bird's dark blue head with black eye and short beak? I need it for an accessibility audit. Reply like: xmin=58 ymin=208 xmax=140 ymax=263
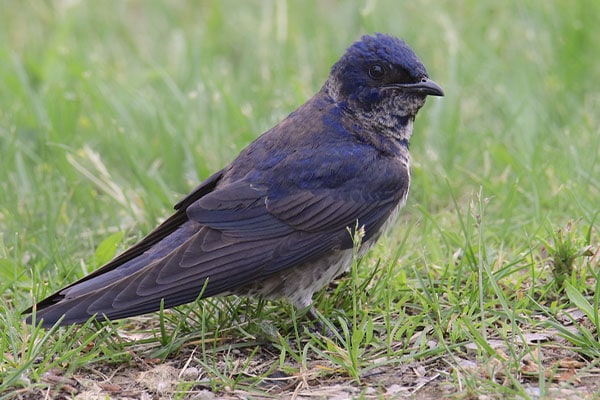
xmin=324 ymin=33 xmax=444 ymax=128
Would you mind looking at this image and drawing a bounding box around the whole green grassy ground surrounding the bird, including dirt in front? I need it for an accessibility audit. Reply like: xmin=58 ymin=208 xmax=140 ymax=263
xmin=0 ymin=0 xmax=600 ymax=399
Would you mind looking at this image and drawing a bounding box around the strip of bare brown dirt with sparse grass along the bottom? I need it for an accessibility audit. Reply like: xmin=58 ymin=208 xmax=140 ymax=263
xmin=14 ymin=333 xmax=600 ymax=400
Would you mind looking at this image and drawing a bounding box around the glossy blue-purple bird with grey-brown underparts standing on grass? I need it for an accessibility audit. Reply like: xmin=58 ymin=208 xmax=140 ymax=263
xmin=25 ymin=33 xmax=444 ymax=327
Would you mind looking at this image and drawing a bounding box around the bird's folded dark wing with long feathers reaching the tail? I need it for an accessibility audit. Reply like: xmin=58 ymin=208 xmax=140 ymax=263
xmin=27 ymin=166 xmax=398 ymax=325
